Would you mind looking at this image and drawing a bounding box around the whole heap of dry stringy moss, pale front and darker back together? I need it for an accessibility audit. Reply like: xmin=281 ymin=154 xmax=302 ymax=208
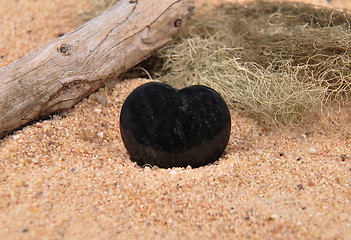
xmin=84 ymin=1 xmax=351 ymax=124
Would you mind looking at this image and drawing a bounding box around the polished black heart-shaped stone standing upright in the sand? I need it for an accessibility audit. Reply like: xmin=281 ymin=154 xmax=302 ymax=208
xmin=120 ymin=82 xmax=231 ymax=168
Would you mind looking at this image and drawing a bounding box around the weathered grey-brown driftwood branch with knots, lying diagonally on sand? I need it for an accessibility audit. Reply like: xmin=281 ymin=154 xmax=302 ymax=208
xmin=0 ymin=0 xmax=192 ymax=138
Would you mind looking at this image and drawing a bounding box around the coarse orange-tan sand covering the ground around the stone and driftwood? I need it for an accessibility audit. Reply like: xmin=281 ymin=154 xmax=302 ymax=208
xmin=0 ymin=0 xmax=351 ymax=239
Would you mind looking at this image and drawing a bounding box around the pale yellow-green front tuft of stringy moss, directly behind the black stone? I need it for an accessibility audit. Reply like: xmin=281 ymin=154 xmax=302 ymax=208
xmin=159 ymin=37 xmax=327 ymax=124
